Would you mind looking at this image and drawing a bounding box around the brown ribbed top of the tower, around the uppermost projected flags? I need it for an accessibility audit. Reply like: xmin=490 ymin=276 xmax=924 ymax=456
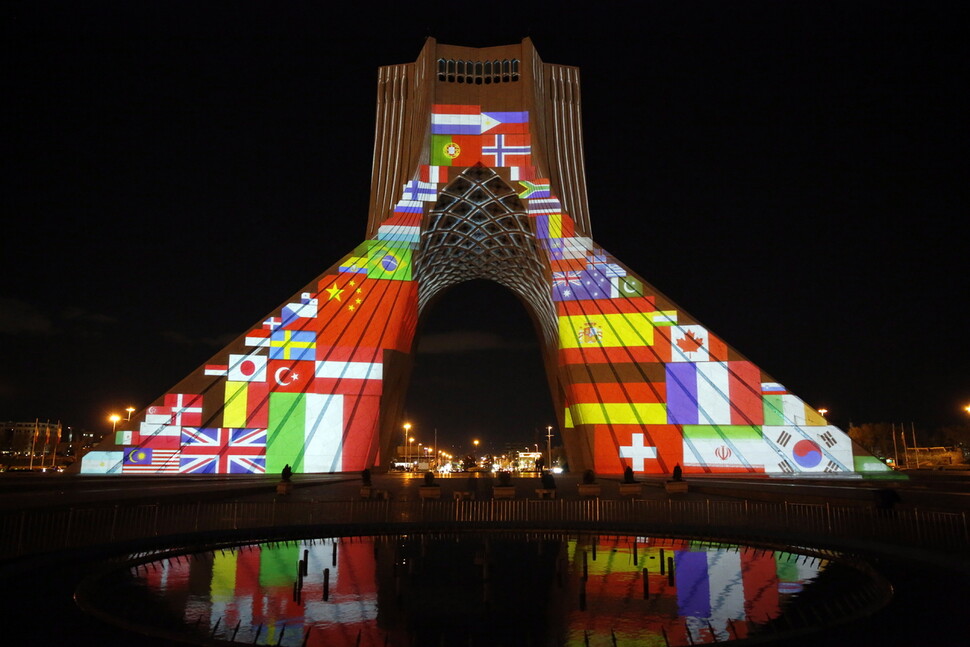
xmin=367 ymin=38 xmax=590 ymax=236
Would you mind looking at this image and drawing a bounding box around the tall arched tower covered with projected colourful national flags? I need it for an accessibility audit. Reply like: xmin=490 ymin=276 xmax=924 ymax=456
xmin=81 ymin=39 xmax=887 ymax=474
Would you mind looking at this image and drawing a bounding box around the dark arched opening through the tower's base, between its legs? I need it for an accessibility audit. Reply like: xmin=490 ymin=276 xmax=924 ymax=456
xmin=404 ymin=280 xmax=558 ymax=464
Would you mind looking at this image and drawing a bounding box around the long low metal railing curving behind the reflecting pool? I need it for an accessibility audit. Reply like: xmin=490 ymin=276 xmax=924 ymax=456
xmin=0 ymin=499 xmax=970 ymax=558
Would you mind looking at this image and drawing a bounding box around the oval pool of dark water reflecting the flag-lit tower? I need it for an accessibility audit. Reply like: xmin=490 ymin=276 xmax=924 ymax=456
xmin=79 ymin=533 xmax=889 ymax=647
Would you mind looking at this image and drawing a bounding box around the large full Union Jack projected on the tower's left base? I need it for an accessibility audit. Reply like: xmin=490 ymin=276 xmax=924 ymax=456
xmin=179 ymin=427 xmax=266 ymax=474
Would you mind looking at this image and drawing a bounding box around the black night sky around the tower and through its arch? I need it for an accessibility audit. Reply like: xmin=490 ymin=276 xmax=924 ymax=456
xmin=0 ymin=2 xmax=970 ymax=454
